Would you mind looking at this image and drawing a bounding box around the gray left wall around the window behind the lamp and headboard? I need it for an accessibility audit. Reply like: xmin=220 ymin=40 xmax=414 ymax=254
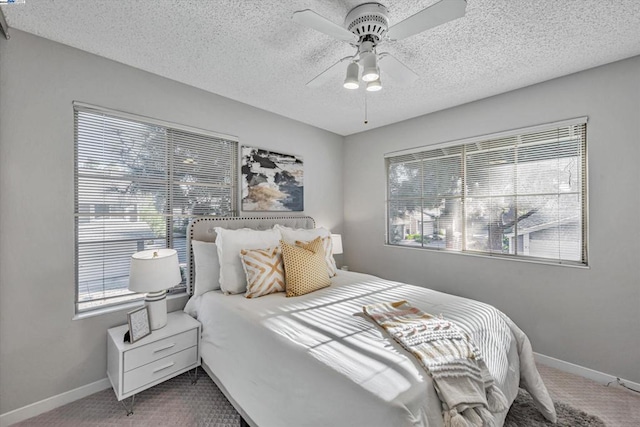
xmin=0 ymin=30 xmax=343 ymax=413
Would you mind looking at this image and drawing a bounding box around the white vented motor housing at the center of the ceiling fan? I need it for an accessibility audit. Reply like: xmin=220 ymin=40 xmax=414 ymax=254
xmin=344 ymin=3 xmax=389 ymax=46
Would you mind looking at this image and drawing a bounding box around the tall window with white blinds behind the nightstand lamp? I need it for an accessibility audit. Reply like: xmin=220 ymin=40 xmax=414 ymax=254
xmin=74 ymin=103 xmax=238 ymax=312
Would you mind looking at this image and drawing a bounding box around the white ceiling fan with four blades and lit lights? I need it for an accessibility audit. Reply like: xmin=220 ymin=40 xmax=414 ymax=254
xmin=292 ymin=0 xmax=467 ymax=91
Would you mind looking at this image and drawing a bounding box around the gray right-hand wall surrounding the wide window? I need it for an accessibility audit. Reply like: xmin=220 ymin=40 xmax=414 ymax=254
xmin=343 ymin=57 xmax=640 ymax=382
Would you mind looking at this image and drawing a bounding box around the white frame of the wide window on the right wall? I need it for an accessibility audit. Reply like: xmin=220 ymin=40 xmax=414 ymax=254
xmin=384 ymin=117 xmax=589 ymax=267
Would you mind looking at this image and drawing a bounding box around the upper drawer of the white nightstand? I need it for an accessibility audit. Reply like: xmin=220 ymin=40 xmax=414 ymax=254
xmin=124 ymin=329 xmax=198 ymax=372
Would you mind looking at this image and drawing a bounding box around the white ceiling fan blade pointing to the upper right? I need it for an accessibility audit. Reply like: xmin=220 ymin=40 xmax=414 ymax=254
xmin=387 ymin=0 xmax=467 ymax=40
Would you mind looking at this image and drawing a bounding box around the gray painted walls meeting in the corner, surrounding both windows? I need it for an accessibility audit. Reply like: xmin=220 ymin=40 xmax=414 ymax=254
xmin=0 ymin=25 xmax=640 ymax=413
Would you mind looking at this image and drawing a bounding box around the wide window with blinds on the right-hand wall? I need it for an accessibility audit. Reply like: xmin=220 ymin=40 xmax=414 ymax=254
xmin=385 ymin=118 xmax=587 ymax=265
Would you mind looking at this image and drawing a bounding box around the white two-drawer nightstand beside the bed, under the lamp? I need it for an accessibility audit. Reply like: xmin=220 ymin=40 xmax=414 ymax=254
xmin=107 ymin=311 xmax=200 ymax=415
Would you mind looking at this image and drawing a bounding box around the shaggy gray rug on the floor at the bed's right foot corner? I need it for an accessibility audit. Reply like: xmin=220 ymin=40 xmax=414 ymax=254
xmin=504 ymin=390 xmax=605 ymax=427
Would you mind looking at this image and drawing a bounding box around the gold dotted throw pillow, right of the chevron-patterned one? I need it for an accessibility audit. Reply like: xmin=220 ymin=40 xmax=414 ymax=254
xmin=280 ymin=237 xmax=331 ymax=297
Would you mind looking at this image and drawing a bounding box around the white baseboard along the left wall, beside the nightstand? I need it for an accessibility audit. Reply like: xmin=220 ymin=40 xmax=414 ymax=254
xmin=0 ymin=378 xmax=111 ymax=427
